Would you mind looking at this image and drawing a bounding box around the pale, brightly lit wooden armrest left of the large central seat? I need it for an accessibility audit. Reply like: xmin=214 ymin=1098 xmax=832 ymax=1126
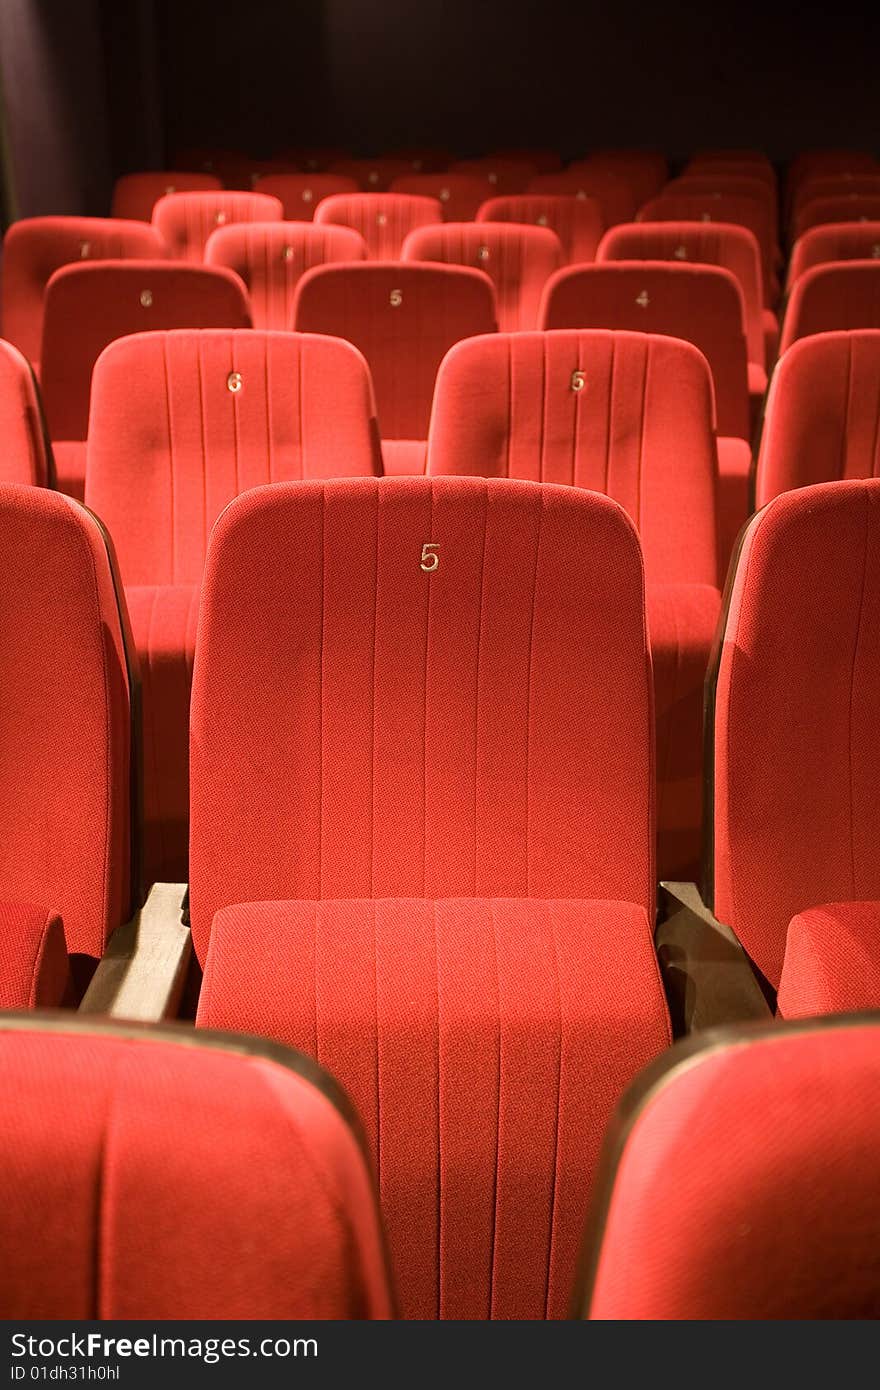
xmin=79 ymin=883 xmax=192 ymax=1023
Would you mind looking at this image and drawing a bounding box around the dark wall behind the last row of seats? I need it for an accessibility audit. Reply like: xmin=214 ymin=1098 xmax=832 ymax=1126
xmin=0 ymin=0 xmax=880 ymax=215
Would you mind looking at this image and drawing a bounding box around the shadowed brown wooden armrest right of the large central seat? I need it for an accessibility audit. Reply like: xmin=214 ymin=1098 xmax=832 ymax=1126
xmin=655 ymin=883 xmax=773 ymax=1037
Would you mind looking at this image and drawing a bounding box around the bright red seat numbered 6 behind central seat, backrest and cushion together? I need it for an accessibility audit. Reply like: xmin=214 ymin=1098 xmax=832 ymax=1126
xmin=86 ymin=331 xmax=380 ymax=883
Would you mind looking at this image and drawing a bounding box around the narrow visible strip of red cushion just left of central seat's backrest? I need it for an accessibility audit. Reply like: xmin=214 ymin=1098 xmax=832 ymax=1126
xmin=125 ymin=585 xmax=199 ymax=884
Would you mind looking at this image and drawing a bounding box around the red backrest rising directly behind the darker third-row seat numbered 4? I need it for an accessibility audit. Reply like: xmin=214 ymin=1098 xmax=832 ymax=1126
xmin=595 ymin=222 xmax=767 ymax=369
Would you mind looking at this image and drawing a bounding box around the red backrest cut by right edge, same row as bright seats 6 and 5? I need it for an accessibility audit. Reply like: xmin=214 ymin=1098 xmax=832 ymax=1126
xmin=756 ymin=328 xmax=880 ymax=507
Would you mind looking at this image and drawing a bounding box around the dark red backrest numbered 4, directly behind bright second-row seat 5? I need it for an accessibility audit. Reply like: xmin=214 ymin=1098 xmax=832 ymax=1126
xmin=541 ymin=261 xmax=749 ymax=439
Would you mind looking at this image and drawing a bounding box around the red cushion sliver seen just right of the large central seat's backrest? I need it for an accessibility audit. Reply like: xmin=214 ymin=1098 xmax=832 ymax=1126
xmin=645 ymin=584 xmax=722 ymax=878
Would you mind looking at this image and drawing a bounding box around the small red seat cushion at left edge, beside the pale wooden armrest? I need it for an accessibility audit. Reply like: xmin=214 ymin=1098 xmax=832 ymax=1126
xmin=0 ymin=902 xmax=70 ymax=1009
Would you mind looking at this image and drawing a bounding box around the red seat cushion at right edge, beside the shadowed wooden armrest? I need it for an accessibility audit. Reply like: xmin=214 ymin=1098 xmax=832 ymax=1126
xmin=777 ymin=902 xmax=880 ymax=1019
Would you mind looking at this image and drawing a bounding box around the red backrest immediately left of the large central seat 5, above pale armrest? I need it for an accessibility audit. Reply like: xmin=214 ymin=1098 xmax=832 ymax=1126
xmin=0 ymin=484 xmax=131 ymax=958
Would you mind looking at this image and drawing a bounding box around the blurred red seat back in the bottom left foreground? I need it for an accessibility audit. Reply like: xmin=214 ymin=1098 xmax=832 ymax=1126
xmin=0 ymin=1023 xmax=391 ymax=1321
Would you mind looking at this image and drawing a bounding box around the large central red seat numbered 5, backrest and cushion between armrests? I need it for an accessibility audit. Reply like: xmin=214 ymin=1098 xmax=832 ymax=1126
xmin=184 ymin=478 xmax=669 ymax=1318
